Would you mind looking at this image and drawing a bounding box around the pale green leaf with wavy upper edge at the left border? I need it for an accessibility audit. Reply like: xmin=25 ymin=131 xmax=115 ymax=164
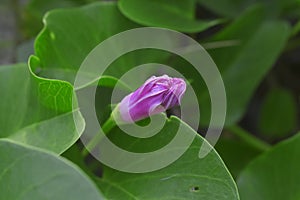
xmin=0 ymin=64 xmax=84 ymax=153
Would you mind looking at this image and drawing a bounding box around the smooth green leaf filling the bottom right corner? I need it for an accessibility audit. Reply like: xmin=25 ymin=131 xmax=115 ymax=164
xmin=238 ymin=133 xmax=300 ymax=200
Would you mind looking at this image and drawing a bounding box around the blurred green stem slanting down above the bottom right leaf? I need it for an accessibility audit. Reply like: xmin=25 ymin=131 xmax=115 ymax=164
xmin=227 ymin=125 xmax=271 ymax=151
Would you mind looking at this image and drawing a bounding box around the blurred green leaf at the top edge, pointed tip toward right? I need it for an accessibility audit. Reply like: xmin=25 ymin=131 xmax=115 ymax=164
xmin=118 ymin=0 xmax=221 ymax=33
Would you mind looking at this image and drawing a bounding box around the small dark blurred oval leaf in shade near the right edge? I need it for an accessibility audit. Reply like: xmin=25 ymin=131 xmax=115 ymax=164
xmin=259 ymin=88 xmax=297 ymax=138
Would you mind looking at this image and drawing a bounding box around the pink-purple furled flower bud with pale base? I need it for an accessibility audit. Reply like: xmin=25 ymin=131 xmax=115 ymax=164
xmin=118 ymin=75 xmax=186 ymax=122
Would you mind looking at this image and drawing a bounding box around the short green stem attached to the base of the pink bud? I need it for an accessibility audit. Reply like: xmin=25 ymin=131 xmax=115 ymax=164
xmin=81 ymin=116 xmax=116 ymax=157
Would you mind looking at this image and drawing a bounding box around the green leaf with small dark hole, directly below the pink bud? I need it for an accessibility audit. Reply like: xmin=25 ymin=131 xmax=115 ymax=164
xmin=97 ymin=117 xmax=239 ymax=200
